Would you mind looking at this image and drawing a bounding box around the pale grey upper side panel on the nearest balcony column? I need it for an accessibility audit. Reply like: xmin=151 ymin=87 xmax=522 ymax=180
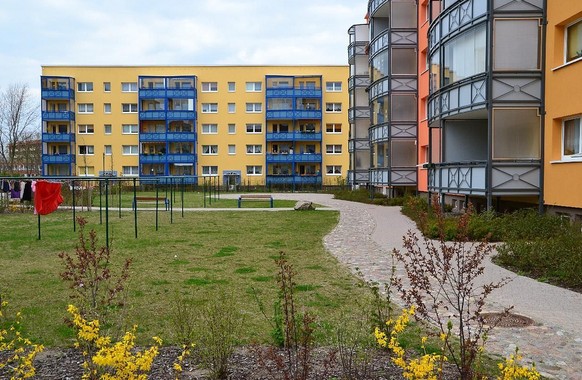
xmin=493 ymin=19 xmax=541 ymax=70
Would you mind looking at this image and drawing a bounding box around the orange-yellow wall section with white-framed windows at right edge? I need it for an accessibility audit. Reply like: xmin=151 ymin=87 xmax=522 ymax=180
xmin=544 ymin=0 xmax=582 ymax=220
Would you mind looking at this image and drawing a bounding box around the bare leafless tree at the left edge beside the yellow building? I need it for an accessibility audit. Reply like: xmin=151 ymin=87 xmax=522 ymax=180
xmin=0 ymin=83 xmax=39 ymax=172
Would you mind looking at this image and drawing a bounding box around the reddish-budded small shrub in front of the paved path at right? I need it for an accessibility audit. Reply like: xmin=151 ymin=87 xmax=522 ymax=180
xmin=393 ymin=197 xmax=509 ymax=380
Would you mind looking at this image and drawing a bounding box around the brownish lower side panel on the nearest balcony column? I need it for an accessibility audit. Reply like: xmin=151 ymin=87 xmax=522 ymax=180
xmin=493 ymin=108 xmax=541 ymax=159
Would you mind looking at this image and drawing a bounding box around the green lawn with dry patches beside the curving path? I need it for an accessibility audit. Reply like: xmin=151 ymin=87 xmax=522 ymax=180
xmin=0 ymin=208 xmax=369 ymax=346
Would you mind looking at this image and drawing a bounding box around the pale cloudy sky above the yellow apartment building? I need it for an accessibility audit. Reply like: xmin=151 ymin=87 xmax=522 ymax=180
xmin=0 ymin=0 xmax=368 ymax=95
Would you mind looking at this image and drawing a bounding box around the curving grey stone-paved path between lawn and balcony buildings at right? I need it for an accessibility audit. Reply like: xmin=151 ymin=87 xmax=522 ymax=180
xmin=274 ymin=193 xmax=582 ymax=380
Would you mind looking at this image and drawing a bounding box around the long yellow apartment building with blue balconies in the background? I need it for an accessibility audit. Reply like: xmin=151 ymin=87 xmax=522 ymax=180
xmin=41 ymin=66 xmax=349 ymax=187
